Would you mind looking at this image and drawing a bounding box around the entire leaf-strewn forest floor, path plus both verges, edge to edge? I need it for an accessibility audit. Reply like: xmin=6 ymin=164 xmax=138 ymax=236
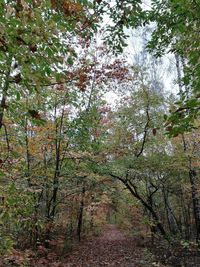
xmin=0 ymin=225 xmax=200 ymax=267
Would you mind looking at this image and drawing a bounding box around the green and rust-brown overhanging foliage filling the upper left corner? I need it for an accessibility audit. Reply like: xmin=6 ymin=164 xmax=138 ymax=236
xmin=0 ymin=0 xmax=100 ymax=128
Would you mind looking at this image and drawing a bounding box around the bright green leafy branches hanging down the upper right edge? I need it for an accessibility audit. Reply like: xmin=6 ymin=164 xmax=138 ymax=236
xmin=146 ymin=1 xmax=200 ymax=136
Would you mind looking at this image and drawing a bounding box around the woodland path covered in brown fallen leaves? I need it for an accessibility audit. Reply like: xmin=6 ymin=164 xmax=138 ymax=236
xmin=64 ymin=225 xmax=158 ymax=267
